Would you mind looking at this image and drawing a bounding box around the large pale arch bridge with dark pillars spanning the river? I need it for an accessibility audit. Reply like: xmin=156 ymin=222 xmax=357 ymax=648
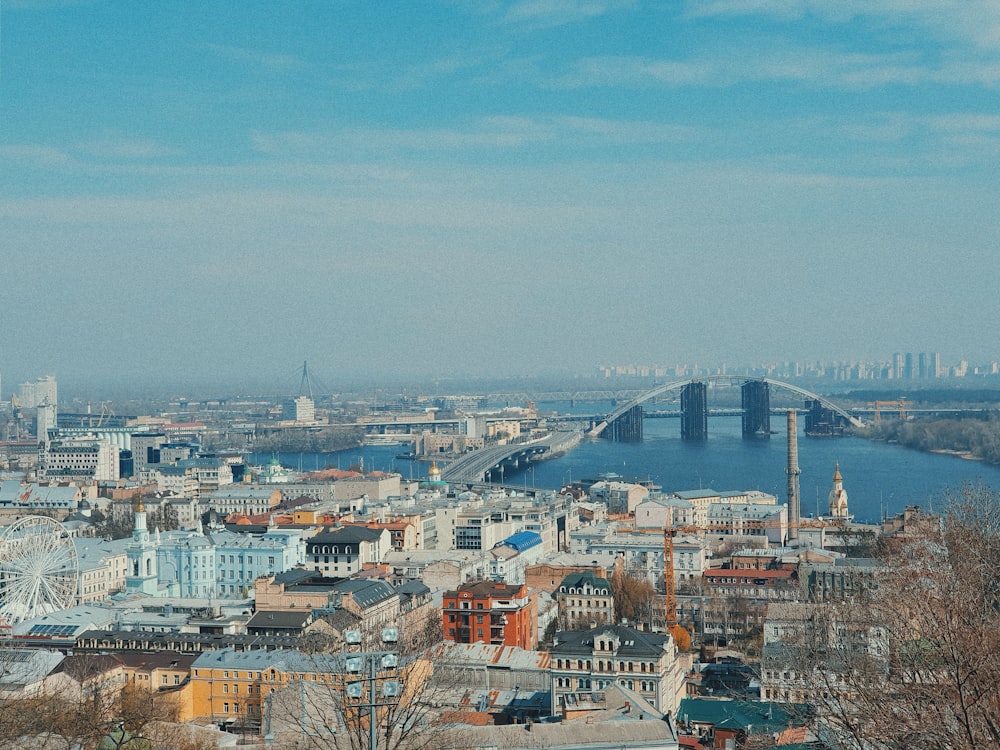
xmin=587 ymin=375 xmax=864 ymax=440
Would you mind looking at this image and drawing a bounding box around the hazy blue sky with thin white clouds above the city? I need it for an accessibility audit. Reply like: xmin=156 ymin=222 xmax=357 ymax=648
xmin=0 ymin=0 xmax=1000 ymax=392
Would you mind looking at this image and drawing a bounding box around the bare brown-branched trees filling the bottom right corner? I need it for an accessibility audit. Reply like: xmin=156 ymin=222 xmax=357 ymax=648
xmin=798 ymin=485 xmax=1000 ymax=750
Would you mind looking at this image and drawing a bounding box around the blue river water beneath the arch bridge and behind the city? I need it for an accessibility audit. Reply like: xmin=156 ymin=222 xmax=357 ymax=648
xmin=252 ymin=404 xmax=1000 ymax=521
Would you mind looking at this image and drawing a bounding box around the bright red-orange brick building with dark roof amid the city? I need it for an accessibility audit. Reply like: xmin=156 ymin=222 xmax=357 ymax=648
xmin=442 ymin=581 xmax=538 ymax=651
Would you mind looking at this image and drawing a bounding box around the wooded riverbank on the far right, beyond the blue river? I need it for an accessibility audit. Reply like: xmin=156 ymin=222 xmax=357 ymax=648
xmin=862 ymin=417 xmax=1000 ymax=465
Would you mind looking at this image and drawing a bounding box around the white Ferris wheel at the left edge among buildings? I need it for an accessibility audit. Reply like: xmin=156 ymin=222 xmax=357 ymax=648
xmin=0 ymin=516 xmax=80 ymax=622
